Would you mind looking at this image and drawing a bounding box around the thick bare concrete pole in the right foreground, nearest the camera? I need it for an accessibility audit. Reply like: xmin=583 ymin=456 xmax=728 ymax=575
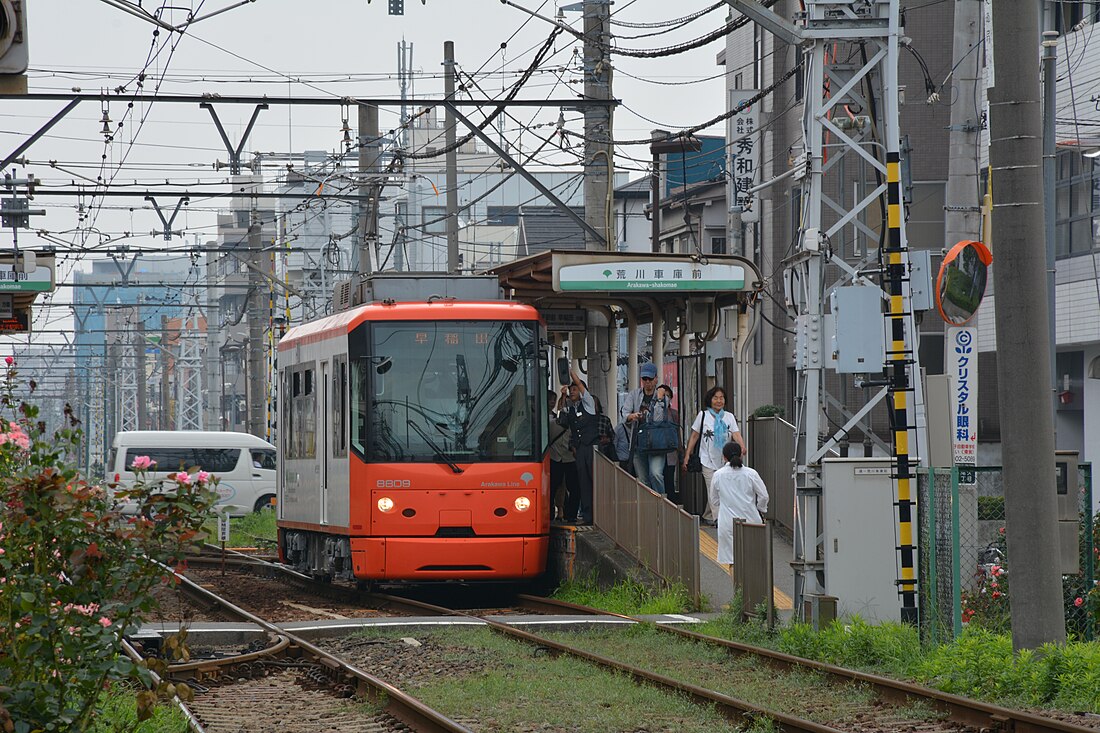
xmin=989 ymin=0 xmax=1066 ymax=649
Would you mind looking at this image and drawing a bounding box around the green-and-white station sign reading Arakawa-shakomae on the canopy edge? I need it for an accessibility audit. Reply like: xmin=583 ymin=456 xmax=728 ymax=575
xmin=554 ymin=259 xmax=745 ymax=293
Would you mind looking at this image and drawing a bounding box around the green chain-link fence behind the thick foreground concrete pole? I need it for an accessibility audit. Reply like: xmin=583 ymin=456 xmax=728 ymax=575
xmin=917 ymin=463 xmax=1100 ymax=643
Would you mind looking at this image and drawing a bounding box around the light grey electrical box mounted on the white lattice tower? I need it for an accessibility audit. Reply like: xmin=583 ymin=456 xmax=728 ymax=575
xmin=829 ymin=285 xmax=887 ymax=374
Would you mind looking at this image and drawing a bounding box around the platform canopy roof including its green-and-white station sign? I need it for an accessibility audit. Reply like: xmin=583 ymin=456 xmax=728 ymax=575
xmin=488 ymin=250 xmax=761 ymax=324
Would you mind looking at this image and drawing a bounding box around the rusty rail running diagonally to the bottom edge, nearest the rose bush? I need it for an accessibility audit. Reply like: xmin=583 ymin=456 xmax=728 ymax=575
xmin=152 ymin=573 xmax=472 ymax=733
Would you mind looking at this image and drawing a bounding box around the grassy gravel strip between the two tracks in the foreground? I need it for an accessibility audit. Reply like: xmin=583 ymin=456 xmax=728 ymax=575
xmin=343 ymin=627 xmax=743 ymax=733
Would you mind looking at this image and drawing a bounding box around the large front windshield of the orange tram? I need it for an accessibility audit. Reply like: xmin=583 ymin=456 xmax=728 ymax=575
xmin=353 ymin=321 xmax=546 ymax=468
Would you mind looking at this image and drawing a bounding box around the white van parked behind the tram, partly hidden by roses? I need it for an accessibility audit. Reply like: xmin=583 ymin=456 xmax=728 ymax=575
xmin=109 ymin=430 xmax=276 ymax=515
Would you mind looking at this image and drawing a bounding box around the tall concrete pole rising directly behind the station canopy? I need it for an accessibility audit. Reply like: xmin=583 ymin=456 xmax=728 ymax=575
xmin=583 ymin=0 xmax=615 ymax=250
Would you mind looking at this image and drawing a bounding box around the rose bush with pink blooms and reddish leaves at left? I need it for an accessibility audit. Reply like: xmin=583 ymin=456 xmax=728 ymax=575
xmin=0 ymin=357 xmax=217 ymax=733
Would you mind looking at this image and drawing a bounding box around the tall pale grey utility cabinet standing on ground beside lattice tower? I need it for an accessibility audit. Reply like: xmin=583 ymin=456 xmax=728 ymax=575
xmin=822 ymin=457 xmax=916 ymax=621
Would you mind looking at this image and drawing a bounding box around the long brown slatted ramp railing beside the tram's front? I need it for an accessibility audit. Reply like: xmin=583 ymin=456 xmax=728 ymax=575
xmin=592 ymin=451 xmax=700 ymax=604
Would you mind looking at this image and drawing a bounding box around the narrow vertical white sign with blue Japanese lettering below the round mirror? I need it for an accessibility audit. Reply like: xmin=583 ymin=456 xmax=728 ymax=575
xmin=946 ymin=326 xmax=978 ymax=485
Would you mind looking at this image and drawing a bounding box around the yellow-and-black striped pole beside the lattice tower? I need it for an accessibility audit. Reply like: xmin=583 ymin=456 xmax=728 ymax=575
xmin=883 ymin=153 xmax=917 ymax=624
